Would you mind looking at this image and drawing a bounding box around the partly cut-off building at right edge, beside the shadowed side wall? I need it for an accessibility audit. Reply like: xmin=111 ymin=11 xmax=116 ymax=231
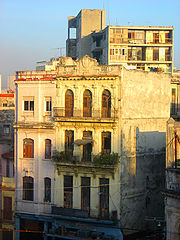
xmin=164 ymin=116 xmax=180 ymax=240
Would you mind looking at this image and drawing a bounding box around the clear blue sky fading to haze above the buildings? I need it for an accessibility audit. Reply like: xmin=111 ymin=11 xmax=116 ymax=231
xmin=0 ymin=0 xmax=180 ymax=88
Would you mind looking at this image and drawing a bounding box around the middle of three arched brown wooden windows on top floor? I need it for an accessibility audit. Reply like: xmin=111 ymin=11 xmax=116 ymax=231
xmin=83 ymin=89 xmax=92 ymax=117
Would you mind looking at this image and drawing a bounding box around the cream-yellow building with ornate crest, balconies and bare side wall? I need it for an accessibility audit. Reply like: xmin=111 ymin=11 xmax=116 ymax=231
xmin=54 ymin=56 xmax=170 ymax=232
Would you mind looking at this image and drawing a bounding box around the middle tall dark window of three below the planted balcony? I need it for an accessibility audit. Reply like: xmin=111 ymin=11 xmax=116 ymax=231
xmin=81 ymin=177 xmax=91 ymax=212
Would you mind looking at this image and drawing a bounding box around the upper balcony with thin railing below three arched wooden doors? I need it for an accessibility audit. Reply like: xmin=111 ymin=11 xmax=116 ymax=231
xmin=53 ymin=107 xmax=118 ymax=123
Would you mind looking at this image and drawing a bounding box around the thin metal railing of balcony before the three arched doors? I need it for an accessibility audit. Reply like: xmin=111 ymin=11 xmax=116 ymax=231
xmin=53 ymin=107 xmax=118 ymax=120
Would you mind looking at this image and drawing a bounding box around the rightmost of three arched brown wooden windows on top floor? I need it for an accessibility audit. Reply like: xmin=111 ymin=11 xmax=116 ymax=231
xmin=101 ymin=90 xmax=111 ymax=118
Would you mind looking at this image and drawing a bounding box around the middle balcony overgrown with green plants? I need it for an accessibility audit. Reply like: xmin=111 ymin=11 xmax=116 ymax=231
xmin=53 ymin=152 xmax=119 ymax=179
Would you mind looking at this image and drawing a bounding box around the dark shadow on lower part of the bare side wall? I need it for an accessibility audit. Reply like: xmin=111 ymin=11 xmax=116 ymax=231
xmin=121 ymin=127 xmax=166 ymax=230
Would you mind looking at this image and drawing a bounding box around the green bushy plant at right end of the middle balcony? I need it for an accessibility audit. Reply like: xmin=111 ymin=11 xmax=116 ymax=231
xmin=93 ymin=153 xmax=119 ymax=166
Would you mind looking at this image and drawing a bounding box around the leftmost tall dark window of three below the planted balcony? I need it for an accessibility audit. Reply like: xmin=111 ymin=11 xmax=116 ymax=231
xmin=64 ymin=175 xmax=73 ymax=208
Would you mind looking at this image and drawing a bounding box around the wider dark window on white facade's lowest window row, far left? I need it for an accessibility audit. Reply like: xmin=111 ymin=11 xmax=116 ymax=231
xmin=23 ymin=177 xmax=34 ymax=201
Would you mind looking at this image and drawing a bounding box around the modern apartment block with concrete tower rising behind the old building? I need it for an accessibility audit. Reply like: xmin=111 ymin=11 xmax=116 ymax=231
xmin=66 ymin=9 xmax=174 ymax=72
